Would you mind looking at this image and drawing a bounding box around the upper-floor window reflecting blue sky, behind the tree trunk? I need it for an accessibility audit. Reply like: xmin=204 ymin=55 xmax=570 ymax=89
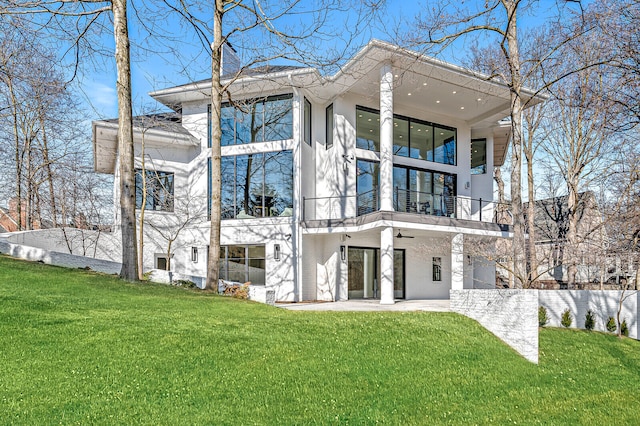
xmin=214 ymin=94 xmax=293 ymax=146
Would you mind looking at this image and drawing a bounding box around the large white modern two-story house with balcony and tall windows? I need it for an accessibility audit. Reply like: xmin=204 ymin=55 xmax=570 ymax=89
xmin=93 ymin=40 xmax=542 ymax=304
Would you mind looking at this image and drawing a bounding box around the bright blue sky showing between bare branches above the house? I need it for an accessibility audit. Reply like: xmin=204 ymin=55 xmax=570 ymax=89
xmin=78 ymin=0 xmax=588 ymax=119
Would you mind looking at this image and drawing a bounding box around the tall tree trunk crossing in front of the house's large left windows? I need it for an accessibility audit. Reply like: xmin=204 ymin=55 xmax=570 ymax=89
xmin=205 ymin=0 xmax=224 ymax=289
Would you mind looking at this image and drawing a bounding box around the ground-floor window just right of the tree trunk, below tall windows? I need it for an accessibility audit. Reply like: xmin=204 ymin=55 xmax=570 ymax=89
xmin=220 ymin=245 xmax=265 ymax=285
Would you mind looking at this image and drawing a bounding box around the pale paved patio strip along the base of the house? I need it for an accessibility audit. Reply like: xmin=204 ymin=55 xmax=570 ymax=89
xmin=276 ymin=299 xmax=451 ymax=312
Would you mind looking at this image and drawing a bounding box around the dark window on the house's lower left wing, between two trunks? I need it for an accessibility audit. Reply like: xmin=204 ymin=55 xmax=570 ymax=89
xmin=136 ymin=169 xmax=173 ymax=212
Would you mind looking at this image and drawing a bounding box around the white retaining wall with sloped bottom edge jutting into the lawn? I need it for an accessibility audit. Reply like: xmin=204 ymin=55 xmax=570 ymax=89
xmin=450 ymin=289 xmax=538 ymax=364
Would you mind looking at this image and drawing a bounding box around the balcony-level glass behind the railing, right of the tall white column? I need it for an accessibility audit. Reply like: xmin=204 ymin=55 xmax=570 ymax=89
xmin=393 ymin=166 xmax=456 ymax=217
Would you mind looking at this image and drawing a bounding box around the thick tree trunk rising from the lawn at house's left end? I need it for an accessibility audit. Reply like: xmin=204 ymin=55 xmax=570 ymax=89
xmin=112 ymin=0 xmax=138 ymax=281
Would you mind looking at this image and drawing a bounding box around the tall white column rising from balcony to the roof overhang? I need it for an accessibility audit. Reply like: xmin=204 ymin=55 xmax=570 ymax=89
xmin=380 ymin=64 xmax=393 ymax=211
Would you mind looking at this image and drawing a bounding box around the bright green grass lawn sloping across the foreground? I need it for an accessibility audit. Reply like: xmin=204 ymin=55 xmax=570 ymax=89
xmin=0 ymin=257 xmax=640 ymax=425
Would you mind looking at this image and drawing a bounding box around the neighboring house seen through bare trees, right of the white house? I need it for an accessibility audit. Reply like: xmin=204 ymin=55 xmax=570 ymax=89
xmin=525 ymin=191 xmax=615 ymax=288
